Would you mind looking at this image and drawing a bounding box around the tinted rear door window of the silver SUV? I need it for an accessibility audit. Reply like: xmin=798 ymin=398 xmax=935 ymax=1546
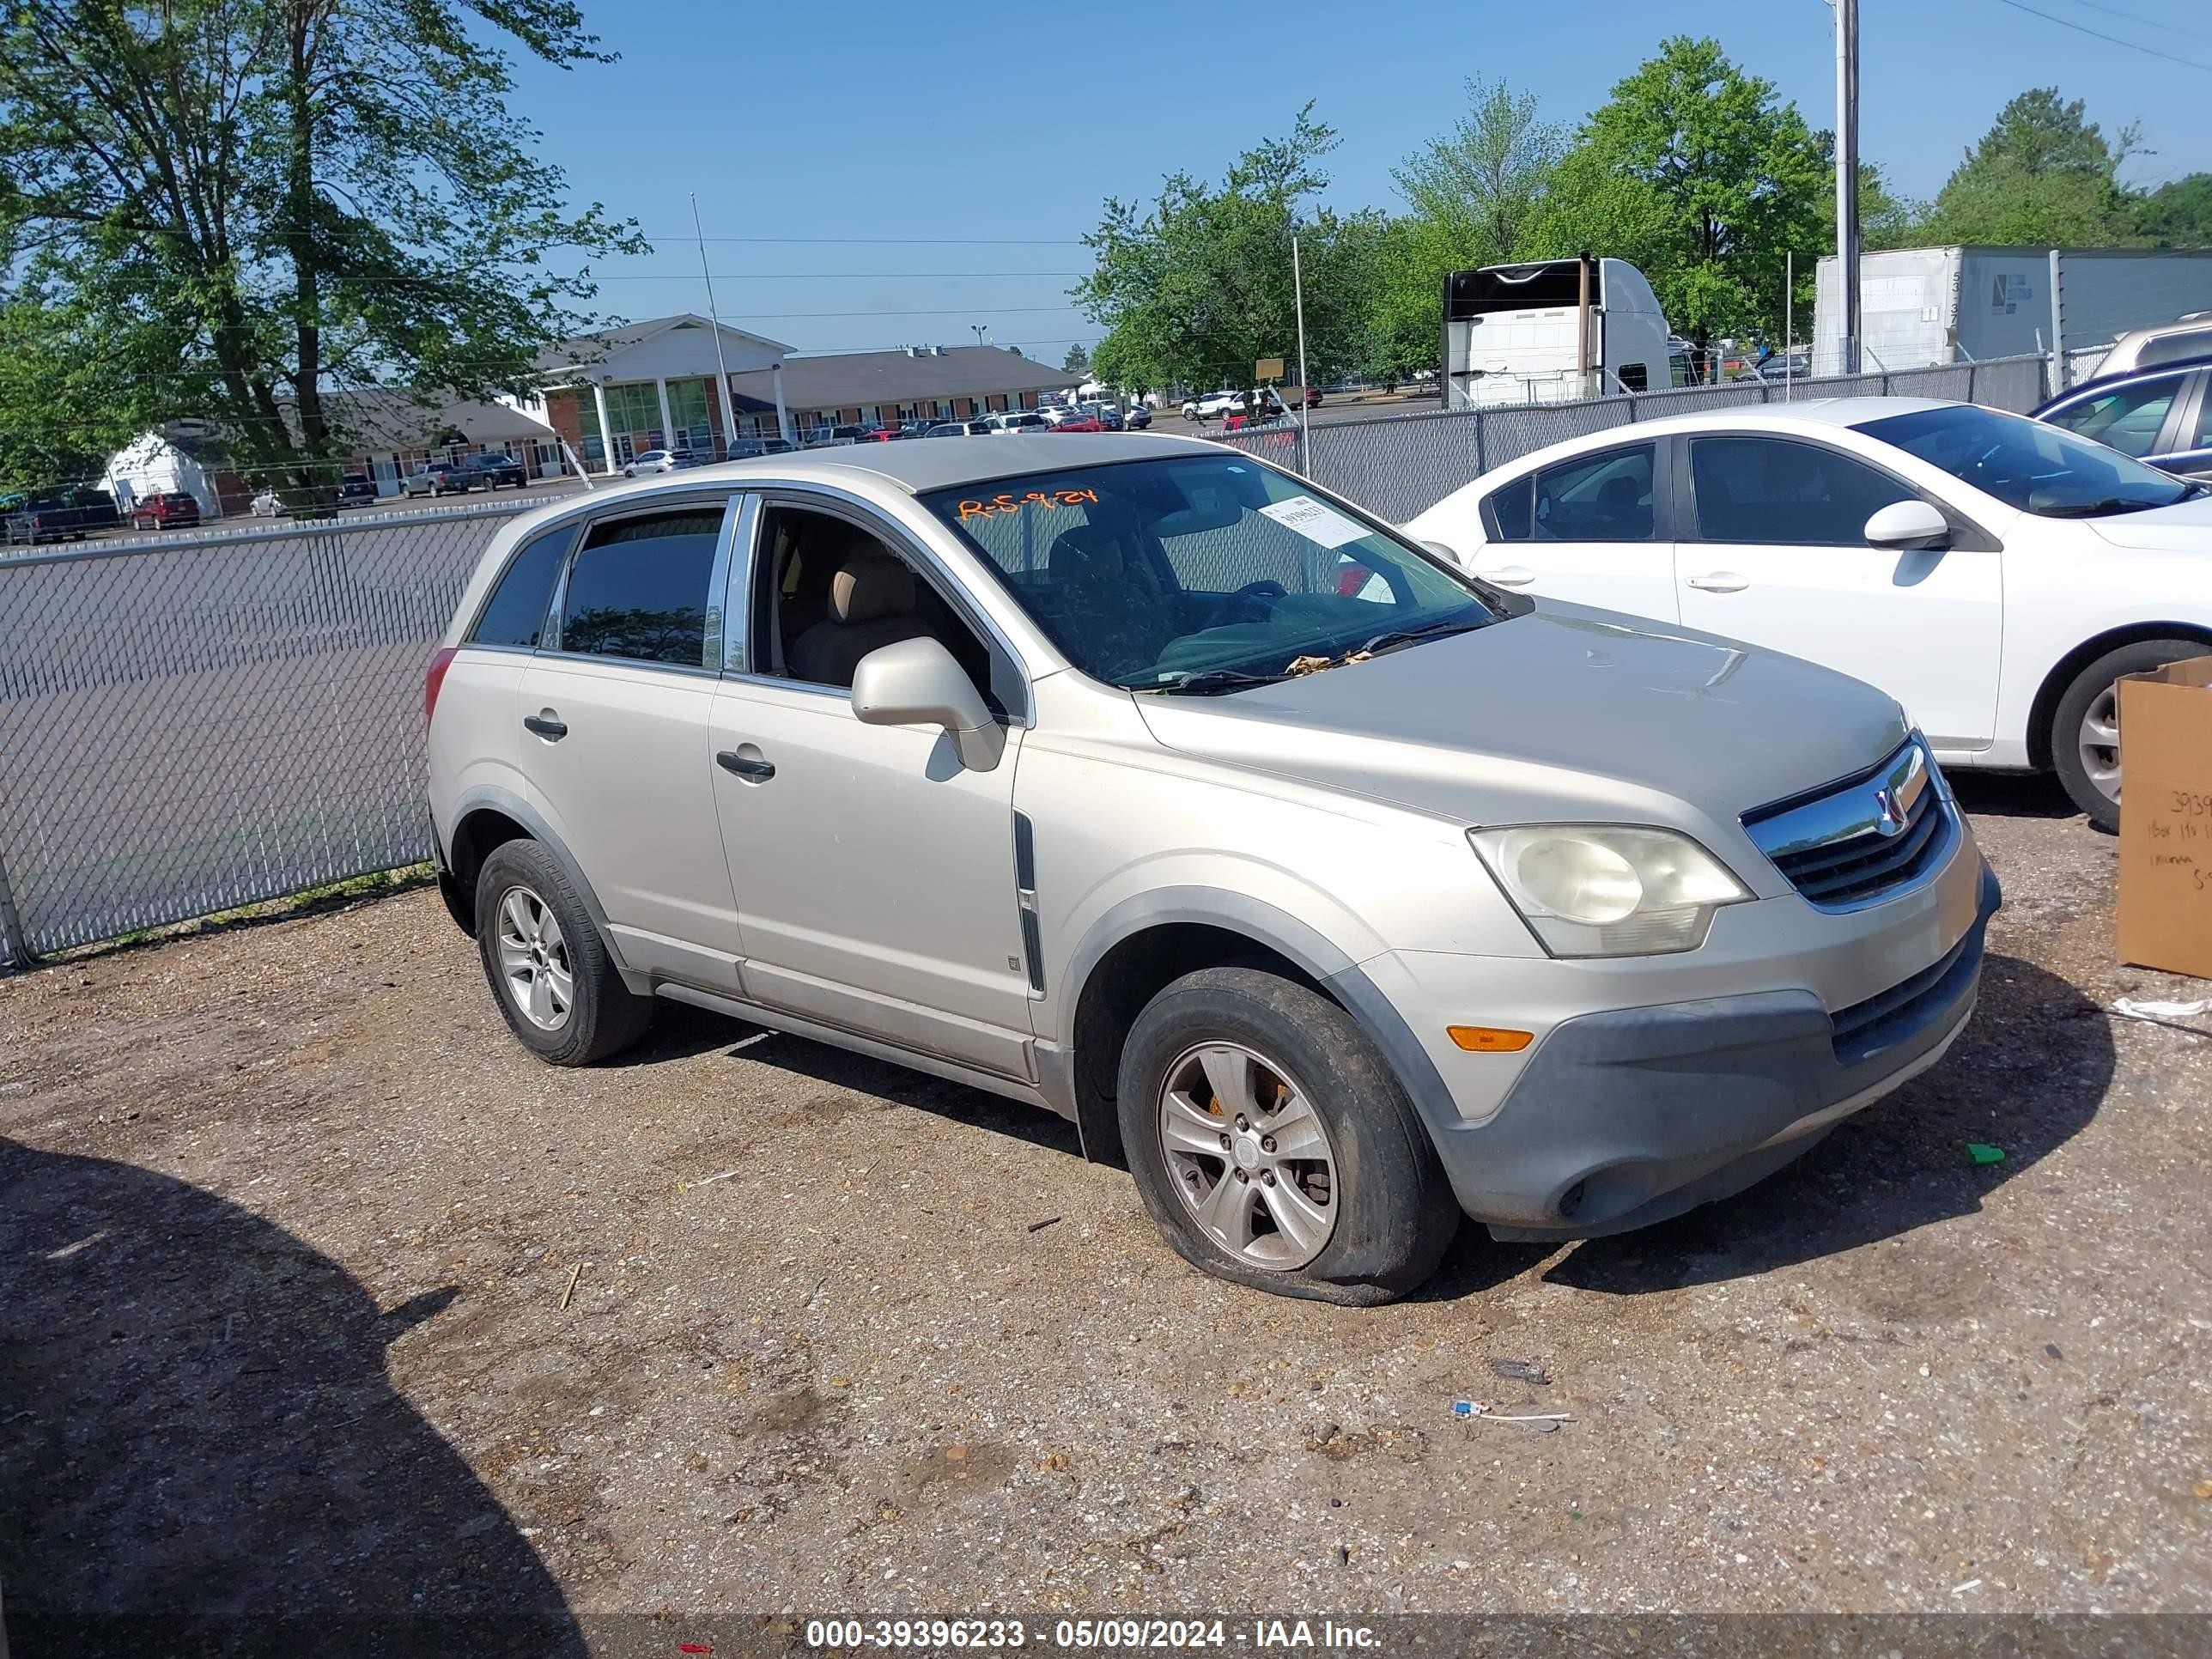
xmin=560 ymin=507 xmax=721 ymax=668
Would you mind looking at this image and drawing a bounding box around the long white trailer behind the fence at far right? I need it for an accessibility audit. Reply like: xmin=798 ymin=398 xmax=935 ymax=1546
xmin=1812 ymin=248 xmax=2212 ymax=374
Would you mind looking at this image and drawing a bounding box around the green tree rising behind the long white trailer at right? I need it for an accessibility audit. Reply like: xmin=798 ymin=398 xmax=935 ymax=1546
xmin=1924 ymin=86 xmax=2136 ymax=248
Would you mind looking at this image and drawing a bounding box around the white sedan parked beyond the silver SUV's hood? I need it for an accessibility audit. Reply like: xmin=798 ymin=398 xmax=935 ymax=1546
xmin=1407 ymin=398 xmax=2212 ymax=830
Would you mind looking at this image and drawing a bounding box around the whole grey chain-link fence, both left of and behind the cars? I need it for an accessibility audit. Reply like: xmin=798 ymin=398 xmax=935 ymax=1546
xmin=0 ymin=358 xmax=2046 ymax=967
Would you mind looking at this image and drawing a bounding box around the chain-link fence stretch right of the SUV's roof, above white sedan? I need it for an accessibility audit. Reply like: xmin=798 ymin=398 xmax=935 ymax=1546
xmin=1221 ymin=356 xmax=2051 ymax=525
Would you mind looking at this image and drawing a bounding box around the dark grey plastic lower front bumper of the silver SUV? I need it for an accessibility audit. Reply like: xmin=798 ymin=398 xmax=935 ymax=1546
xmin=1338 ymin=862 xmax=2002 ymax=1239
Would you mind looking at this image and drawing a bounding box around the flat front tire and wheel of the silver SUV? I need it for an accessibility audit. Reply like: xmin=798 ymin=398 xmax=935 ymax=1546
xmin=1117 ymin=969 xmax=1460 ymax=1305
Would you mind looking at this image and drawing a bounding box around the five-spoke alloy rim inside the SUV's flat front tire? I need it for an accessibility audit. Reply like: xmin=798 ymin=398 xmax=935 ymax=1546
xmin=1159 ymin=1042 xmax=1338 ymax=1272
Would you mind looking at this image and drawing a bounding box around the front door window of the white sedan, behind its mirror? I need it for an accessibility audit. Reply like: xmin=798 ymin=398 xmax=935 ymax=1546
xmin=1690 ymin=438 xmax=1916 ymax=546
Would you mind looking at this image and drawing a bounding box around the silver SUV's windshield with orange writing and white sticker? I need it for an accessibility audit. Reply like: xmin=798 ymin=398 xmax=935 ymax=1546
xmin=921 ymin=453 xmax=1500 ymax=692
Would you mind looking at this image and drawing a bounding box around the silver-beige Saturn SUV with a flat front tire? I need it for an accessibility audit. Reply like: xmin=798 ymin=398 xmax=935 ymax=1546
xmin=425 ymin=434 xmax=1997 ymax=1303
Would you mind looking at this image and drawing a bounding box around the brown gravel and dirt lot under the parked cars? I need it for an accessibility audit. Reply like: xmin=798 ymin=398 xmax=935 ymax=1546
xmin=0 ymin=783 xmax=2212 ymax=1655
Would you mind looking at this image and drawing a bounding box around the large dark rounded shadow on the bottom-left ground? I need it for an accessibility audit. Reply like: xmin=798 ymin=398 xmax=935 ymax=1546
xmin=0 ymin=1139 xmax=581 ymax=1655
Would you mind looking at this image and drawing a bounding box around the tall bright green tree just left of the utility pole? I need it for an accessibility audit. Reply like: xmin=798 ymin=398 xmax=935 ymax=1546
xmin=1531 ymin=35 xmax=1825 ymax=345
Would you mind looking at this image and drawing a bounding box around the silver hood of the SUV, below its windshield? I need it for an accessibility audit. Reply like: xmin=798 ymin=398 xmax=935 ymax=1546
xmin=1137 ymin=602 xmax=1907 ymax=827
